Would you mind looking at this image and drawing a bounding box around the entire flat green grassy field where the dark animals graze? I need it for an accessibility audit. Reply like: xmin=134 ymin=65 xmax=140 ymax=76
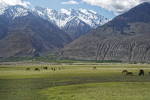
xmin=0 ymin=63 xmax=150 ymax=100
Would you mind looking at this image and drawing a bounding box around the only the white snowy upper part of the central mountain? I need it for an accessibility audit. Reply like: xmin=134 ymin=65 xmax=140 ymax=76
xmin=34 ymin=7 xmax=108 ymax=28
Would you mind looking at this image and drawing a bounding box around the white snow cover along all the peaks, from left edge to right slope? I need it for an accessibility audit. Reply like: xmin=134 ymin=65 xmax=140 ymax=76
xmin=0 ymin=3 xmax=109 ymax=28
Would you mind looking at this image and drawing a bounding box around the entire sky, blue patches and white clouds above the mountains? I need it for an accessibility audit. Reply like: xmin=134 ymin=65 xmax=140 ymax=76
xmin=0 ymin=0 xmax=150 ymax=18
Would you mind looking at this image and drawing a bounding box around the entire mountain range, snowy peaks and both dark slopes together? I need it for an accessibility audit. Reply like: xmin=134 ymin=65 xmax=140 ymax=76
xmin=0 ymin=3 xmax=150 ymax=62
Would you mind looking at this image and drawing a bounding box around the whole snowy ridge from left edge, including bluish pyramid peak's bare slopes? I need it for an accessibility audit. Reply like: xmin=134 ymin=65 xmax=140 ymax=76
xmin=0 ymin=3 xmax=109 ymax=40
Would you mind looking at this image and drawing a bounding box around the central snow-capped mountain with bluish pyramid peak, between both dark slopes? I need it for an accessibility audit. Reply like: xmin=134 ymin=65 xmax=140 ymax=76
xmin=33 ymin=7 xmax=109 ymax=40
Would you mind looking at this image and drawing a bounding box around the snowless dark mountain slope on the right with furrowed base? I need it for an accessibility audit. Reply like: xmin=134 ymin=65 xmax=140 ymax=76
xmin=61 ymin=3 xmax=150 ymax=62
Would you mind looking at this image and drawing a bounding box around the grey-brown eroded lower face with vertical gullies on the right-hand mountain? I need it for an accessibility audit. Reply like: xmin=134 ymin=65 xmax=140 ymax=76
xmin=64 ymin=36 xmax=150 ymax=62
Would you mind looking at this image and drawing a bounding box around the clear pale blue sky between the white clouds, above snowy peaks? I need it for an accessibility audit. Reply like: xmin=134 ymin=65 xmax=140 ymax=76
xmin=26 ymin=0 xmax=115 ymax=18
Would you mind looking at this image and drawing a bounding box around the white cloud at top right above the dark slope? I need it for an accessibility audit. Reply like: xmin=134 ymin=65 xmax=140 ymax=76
xmin=82 ymin=0 xmax=150 ymax=14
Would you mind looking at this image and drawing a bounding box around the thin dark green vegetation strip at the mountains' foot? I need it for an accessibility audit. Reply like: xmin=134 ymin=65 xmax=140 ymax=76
xmin=0 ymin=56 xmax=121 ymax=63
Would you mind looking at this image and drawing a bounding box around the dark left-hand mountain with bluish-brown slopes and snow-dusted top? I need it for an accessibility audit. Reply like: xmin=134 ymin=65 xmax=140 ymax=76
xmin=0 ymin=6 xmax=71 ymax=57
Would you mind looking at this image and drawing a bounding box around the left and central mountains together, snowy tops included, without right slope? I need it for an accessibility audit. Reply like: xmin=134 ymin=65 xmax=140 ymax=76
xmin=0 ymin=3 xmax=108 ymax=57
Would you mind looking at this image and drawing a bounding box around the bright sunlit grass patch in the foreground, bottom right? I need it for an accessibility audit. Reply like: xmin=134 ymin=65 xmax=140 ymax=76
xmin=41 ymin=82 xmax=150 ymax=100
